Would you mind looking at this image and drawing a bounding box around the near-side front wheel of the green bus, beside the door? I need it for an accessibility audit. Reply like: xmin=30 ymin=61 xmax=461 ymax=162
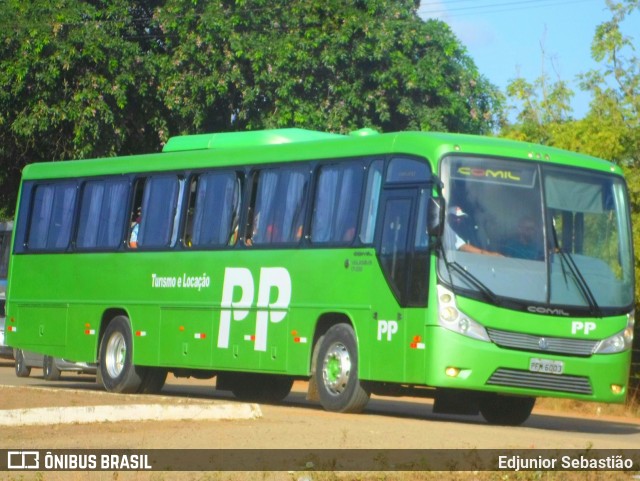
xmin=314 ymin=324 xmax=369 ymax=413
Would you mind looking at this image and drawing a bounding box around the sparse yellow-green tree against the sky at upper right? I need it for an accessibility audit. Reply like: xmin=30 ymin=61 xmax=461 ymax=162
xmin=501 ymin=0 xmax=640 ymax=163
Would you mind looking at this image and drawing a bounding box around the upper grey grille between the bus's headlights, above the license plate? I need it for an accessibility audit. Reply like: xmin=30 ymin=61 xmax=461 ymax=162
xmin=487 ymin=329 xmax=598 ymax=356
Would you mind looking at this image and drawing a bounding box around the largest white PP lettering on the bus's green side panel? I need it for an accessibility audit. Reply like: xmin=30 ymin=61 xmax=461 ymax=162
xmin=218 ymin=267 xmax=291 ymax=351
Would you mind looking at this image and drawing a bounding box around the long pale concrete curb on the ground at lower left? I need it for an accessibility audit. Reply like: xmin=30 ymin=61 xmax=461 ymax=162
xmin=0 ymin=403 xmax=262 ymax=426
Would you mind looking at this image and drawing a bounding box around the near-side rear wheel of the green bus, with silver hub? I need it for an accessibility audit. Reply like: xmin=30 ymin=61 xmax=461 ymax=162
xmin=99 ymin=316 xmax=145 ymax=393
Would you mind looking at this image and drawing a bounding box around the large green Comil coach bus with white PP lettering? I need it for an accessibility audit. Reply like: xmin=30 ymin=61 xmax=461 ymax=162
xmin=7 ymin=129 xmax=634 ymax=425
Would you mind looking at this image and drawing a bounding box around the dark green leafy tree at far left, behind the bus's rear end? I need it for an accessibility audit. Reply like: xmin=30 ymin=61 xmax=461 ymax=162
xmin=0 ymin=0 xmax=170 ymax=214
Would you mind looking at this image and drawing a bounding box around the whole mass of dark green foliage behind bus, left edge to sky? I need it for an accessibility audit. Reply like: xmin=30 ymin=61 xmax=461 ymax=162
xmin=0 ymin=0 xmax=500 ymax=212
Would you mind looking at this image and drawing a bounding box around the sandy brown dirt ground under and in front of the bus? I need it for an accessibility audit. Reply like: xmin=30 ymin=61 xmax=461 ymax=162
xmin=0 ymin=375 xmax=640 ymax=481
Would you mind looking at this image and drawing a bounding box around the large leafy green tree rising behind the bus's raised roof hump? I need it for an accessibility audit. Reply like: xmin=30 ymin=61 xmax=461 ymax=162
xmin=155 ymin=0 xmax=499 ymax=133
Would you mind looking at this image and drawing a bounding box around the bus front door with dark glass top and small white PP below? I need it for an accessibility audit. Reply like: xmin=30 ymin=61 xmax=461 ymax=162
xmin=369 ymin=187 xmax=429 ymax=382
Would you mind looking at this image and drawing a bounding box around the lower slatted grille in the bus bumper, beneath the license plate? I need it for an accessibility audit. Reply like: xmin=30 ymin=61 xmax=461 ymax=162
xmin=487 ymin=368 xmax=593 ymax=395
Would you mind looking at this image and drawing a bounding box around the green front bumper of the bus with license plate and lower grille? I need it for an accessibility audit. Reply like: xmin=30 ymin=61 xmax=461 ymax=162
xmin=426 ymin=326 xmax=631 ymax=403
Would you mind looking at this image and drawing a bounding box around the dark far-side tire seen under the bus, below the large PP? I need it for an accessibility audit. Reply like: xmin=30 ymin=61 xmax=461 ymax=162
xmin=230 ymin=373 xmax=293 ymax=403
